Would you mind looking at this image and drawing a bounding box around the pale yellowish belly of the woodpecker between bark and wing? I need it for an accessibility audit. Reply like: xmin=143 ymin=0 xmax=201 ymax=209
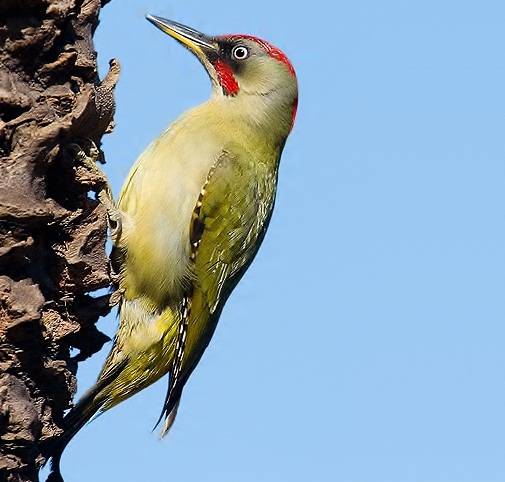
xmin=119 ymin=131 xmax=218 ymax=310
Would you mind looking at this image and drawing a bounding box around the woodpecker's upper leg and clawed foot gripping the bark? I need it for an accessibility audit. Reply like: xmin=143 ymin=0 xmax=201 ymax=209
xmin=67 ymin=139 xmax=122 ymax=242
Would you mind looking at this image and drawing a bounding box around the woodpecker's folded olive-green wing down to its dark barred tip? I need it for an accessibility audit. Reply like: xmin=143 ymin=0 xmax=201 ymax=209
xmin=158 ymin=148 xmax=277 ymax=434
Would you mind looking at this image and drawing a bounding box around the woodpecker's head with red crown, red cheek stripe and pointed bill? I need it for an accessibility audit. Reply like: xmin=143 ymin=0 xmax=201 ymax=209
xmin=147 ymin=15 xmax=298 ymax=132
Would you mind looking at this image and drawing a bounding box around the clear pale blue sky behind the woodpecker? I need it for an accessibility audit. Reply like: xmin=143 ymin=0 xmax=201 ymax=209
xmin=44 ymin=0 xmax=505 ymax=482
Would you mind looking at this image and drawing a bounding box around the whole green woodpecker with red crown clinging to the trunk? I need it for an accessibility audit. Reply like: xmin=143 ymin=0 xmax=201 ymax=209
xmin=46 ymin=16 xmax=298 ymax=480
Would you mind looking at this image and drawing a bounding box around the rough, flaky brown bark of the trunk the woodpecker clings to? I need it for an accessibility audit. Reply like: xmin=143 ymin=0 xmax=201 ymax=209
xmin=0 ymin=0 xmax=119 ymax=482
